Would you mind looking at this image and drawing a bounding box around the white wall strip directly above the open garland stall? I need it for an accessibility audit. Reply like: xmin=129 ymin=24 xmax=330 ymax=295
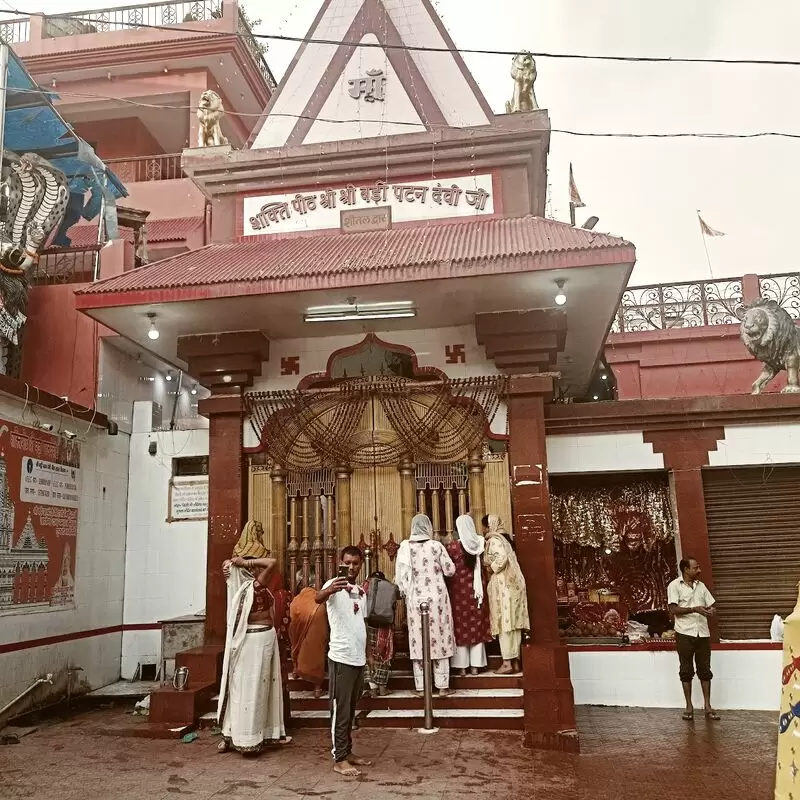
xmin=547 ymin=431 xmax=664 ymax=475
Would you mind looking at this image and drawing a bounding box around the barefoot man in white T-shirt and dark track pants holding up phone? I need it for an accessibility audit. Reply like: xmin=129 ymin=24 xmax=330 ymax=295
xmin=316 ymin=545 xmax=372 ymax=778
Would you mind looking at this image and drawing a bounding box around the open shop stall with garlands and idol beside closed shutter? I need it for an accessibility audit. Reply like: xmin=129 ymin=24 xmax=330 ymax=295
xmin=551 ymin=475 xmax=677 ymax=646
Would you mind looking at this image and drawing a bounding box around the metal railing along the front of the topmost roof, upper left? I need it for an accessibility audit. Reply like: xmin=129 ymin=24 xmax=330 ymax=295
xmin=44 ymin=0 xmax=222 ymax=38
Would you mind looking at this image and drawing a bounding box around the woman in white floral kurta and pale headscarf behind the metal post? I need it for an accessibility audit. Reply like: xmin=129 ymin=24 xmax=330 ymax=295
xmin=395 ymin=514 xmax=456 ymax=696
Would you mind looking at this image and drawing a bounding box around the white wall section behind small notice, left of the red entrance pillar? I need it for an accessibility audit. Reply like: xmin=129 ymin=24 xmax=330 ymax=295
xmin=121 ymin=402 xmax=208 ymax=679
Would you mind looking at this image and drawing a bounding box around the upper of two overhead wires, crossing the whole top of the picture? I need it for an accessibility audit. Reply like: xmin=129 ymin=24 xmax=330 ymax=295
xmin=3 ymin=0 xmax=800 ymax=67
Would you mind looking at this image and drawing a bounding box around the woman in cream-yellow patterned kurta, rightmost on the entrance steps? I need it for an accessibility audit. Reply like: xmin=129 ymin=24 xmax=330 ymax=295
xmin=483 ymin=514 xmax=531 ymax=675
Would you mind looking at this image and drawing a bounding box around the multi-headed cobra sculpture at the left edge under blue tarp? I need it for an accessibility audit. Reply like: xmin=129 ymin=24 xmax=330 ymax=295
xmin=0 ymin=150 xmax=69 ymax=344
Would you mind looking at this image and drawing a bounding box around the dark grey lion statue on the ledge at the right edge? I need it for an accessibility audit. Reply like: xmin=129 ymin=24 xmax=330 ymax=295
xmin=742 ymin=297 xmax=800 ymax=394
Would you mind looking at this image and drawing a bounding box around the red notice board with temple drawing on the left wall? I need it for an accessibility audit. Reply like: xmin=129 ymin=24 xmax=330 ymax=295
xmin=0 ymin=419 xmax=80 ymax=614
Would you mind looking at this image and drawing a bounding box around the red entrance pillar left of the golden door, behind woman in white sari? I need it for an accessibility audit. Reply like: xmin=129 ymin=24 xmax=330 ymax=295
xmin=203 ymin=395 xmax=247 ymax=645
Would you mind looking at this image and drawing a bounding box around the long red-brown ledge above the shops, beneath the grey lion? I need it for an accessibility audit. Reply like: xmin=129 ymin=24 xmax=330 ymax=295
xmin=545 ymin=394 xmax=800 ymax=436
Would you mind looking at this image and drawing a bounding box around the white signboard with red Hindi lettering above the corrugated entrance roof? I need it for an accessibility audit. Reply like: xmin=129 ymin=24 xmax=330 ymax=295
xmin=243 ymin=174 xmax=494 ymax=236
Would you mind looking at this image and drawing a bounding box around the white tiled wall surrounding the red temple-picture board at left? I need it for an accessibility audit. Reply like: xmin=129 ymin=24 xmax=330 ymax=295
xmin=0 ymin=395 xmax=129 ymax=710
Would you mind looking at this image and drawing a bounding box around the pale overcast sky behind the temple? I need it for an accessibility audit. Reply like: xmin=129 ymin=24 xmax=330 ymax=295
xmin=6 ymin=0 xmax=800 ymax=285
